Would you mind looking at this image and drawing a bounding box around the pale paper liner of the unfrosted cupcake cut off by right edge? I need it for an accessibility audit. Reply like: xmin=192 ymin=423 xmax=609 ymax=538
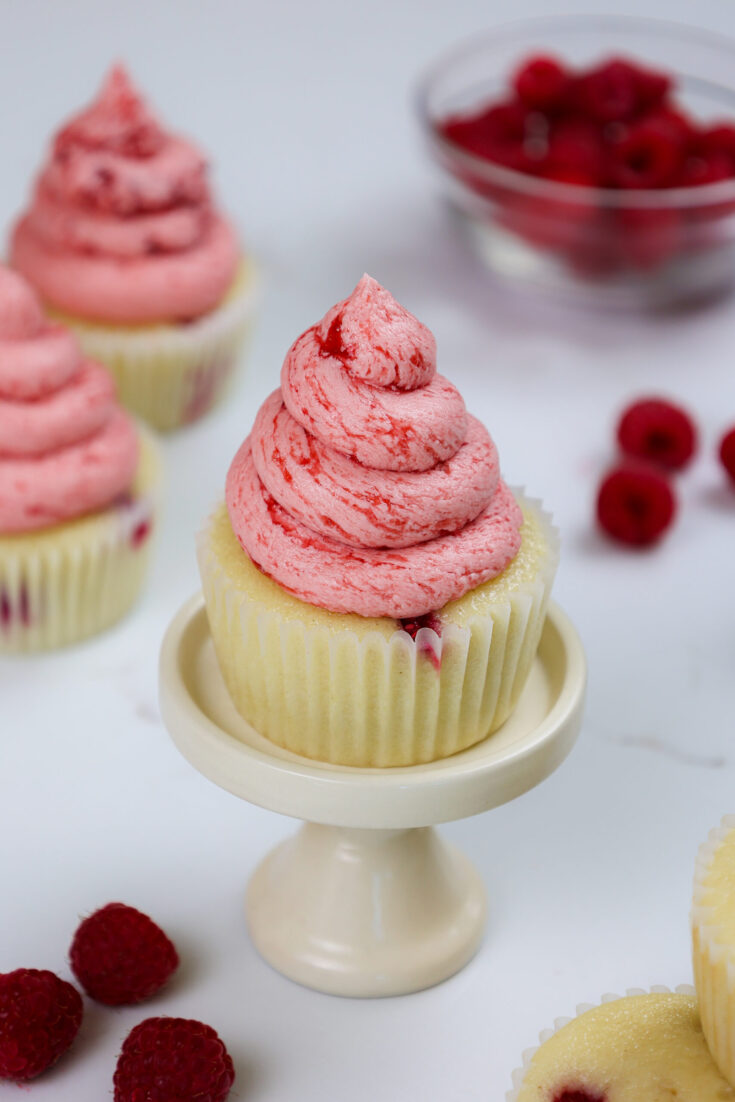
xmin=691 ymin=815 xmax=735 ymax=1087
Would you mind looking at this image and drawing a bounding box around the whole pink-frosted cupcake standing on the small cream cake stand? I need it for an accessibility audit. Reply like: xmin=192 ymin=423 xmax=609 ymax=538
xmin=198 ymin=276 xmax=556 ymax=766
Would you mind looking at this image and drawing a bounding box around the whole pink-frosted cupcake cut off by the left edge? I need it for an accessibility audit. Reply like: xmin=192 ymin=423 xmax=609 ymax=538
xmin=0 ymin=268 xmax=158 ymax=653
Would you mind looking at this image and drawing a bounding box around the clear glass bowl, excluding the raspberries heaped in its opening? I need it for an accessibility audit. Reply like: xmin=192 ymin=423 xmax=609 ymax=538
xmin=418 ymin=15 xmax=735 ymax=307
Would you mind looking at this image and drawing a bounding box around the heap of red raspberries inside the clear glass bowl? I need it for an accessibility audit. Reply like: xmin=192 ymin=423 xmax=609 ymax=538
xmin=437 ymin=53 xmax=735 ymax=274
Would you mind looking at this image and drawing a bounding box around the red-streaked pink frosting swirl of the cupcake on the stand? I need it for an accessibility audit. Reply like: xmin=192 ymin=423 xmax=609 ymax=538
xmin=226 ymin=276 xmax=522 ymax=619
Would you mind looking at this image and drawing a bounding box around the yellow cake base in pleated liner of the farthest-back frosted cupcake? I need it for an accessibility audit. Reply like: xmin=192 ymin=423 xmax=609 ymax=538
xmin=52 ymin=262 xmax=257 ymax=432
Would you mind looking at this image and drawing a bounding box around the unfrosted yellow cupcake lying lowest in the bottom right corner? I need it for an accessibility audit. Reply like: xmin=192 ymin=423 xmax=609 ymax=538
xmin=507 ymin=987 xmax=735 ymax=1102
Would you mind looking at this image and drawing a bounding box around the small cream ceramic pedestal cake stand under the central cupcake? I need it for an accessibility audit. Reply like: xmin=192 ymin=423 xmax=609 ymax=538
xmin=161 ymin=596 xmax=585 ymax=996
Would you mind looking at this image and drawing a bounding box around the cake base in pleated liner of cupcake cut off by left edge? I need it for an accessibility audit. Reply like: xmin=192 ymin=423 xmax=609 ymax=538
xmin=0 ymin=423 xmax=161 ymax=655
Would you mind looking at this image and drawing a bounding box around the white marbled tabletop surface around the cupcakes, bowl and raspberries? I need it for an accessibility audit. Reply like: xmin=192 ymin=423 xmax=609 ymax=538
xmin=0 ymin=0 xmax=735 ymax=1102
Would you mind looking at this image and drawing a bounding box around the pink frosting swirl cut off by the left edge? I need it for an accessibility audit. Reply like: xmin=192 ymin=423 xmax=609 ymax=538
xmin=0 ymin=267 xmax=139 ymax=533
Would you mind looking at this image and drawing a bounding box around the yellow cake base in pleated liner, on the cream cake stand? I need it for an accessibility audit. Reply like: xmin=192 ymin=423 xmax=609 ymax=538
xmin=198 ymin=501 xmax=559 ymax=767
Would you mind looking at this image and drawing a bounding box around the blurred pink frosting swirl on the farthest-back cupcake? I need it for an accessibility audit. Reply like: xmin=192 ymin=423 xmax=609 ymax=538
xmin=11 ymin=66 xmax=238 ymax=323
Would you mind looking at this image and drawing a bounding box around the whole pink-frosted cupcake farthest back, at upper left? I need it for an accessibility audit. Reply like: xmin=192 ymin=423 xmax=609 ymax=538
xmin=10 ymin=66 xmax=253 ymax=430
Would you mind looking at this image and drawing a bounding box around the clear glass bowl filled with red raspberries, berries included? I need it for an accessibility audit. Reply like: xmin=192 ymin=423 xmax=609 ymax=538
xmin=418 ymin=15 xmax=735 ymax=307
